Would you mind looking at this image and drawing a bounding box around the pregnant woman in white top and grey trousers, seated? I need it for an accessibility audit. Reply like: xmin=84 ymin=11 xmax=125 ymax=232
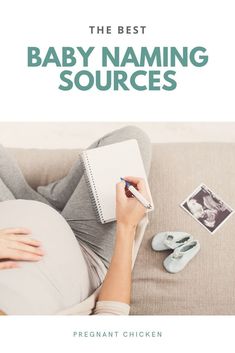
xmin=0 ymin=126 xmax=151 ymax=315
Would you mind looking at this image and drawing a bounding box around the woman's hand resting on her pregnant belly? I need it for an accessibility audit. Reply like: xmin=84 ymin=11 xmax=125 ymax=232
xmin=0 ymin=228 xmax=43 ymax=270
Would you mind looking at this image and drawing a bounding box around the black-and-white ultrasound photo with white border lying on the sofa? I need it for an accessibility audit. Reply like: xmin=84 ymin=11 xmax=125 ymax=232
xmin=180 ymin=184 xmax=234 ymax=234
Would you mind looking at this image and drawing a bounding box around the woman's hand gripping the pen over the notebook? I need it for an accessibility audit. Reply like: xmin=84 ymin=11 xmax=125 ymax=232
xmin=116 ymin=177 xmax=148 ymax=228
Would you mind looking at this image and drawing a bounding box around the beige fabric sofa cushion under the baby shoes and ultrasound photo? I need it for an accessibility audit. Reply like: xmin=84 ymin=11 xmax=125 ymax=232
xmin=131 ymin=143 xmax=235 ymax=315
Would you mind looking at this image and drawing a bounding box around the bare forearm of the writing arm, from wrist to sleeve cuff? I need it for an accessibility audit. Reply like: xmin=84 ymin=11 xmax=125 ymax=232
xmin=98 ymin=224 xmax=136 ymax=304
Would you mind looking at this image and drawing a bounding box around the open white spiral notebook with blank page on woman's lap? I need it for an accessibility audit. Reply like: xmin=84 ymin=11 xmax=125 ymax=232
xmin=81 ymin=139 xmax=154 ymax=223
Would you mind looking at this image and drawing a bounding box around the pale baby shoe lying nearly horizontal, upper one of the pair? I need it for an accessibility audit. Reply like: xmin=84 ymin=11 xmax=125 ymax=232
xmin=152 ymin=232 xmax=193 ymax=251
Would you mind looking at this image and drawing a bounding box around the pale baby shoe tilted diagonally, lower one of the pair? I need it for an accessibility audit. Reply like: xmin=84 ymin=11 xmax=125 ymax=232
xmin=163 ymin=240 xmax=200 ymax=273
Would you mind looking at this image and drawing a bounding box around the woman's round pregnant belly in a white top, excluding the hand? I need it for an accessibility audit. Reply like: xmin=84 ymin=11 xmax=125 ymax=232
xmin=0 ymin=200 xmax=93 ymax=314
